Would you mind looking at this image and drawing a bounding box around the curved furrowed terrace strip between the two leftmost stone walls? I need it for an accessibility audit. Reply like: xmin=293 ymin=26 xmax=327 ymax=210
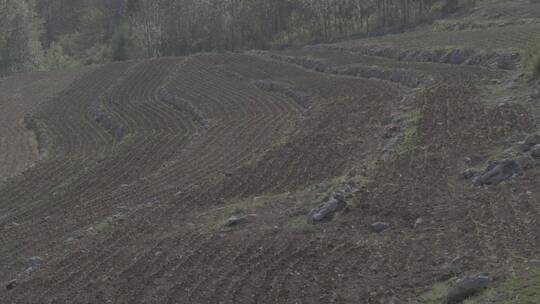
xmin=3 ymin=61 xmax=142 ymax=270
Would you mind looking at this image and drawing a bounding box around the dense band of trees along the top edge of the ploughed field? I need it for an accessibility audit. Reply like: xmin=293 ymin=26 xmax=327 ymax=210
xmin=0 ymin=0 xmax=474 ymax=75
